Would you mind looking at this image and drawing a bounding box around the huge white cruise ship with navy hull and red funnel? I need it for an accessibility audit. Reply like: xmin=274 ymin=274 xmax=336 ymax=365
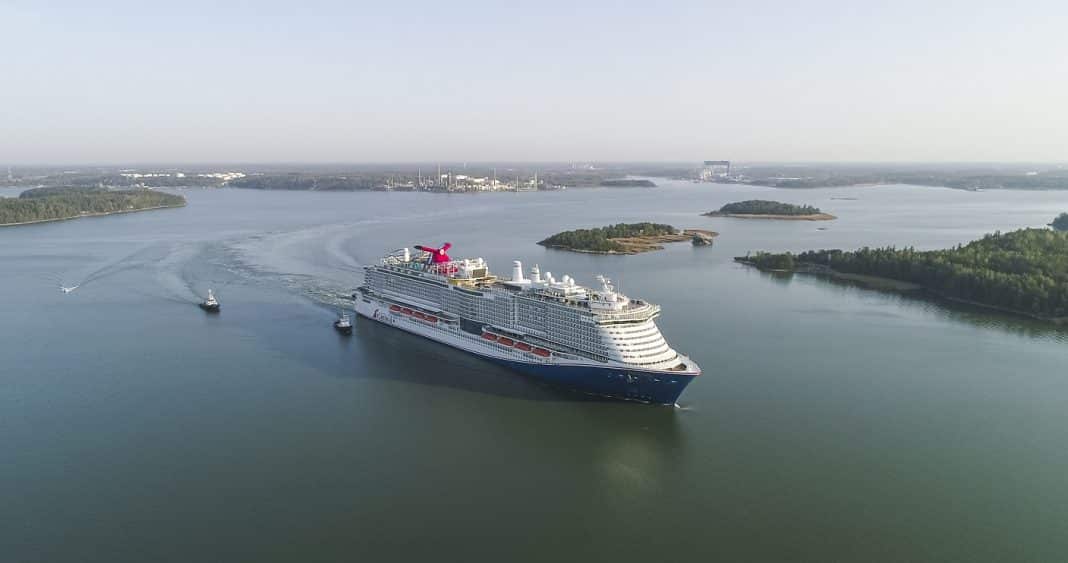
xmin=352 ymin=244 xmax=701 ymax=405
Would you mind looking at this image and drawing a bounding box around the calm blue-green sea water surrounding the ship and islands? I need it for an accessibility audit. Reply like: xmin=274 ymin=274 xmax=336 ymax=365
xmin=0 ymin=183 xmax=1068 ymax=562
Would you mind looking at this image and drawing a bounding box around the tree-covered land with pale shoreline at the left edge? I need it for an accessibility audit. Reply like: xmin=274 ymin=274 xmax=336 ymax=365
xmin=0 ymin=187 xmax=186 ymax=226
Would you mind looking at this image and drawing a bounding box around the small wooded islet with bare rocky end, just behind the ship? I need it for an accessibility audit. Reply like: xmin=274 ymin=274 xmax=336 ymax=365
xmin=538 ymin=222 xmax=718 ymax=254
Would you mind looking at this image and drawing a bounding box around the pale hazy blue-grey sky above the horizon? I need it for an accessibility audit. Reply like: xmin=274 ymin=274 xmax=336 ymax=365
xmin=0 ymin=0 xmax=1068 ymax=163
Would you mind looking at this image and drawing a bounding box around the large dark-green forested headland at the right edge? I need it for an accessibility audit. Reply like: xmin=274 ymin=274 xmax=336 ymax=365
xmin=736 ymin=229 xmax=1068 ymax=320
